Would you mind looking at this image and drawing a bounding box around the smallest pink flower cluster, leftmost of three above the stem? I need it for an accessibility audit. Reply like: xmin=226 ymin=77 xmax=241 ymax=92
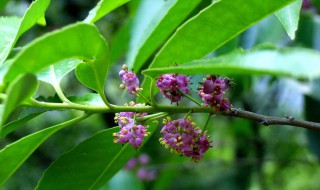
xmin=119 ymin=65 xmax=141 ymax=94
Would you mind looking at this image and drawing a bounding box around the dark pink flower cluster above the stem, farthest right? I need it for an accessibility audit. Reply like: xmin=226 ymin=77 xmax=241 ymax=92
xmin=198 ymin=75 xmax=231 ymax=112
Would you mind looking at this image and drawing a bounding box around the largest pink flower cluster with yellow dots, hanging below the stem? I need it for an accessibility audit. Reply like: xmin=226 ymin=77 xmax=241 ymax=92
xmin=160 ymin=117 xmax=211 ymax=162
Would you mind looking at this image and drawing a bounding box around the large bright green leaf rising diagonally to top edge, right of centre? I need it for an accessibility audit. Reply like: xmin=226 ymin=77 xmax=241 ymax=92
xmin=138 ymin=0 xmax=294 ymax=102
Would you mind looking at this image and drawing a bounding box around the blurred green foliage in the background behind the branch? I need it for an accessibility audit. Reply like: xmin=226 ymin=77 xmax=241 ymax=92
xmin=0 ymin=0 xmax=320 ymax=190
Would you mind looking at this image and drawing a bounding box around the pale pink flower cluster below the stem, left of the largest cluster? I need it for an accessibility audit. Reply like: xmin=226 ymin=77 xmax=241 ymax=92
xmin=113 ymin=102 xmax=148 ymax=149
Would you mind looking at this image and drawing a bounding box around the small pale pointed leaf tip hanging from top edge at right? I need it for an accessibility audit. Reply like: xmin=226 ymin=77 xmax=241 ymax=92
xmin=276 ymin=0 xmax=302 ymax=40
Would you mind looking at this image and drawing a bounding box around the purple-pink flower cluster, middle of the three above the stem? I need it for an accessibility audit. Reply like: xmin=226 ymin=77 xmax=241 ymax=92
xmin=156 ymin=74 xmax=189 ymax=102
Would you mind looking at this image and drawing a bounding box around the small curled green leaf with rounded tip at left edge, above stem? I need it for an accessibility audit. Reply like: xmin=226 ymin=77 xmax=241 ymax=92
xmin=0 ymin=74 xmax=38 ymax=126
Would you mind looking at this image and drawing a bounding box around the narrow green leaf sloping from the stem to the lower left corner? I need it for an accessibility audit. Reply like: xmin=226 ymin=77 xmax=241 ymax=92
xmin=0 ymin=115 xmax=88 ymax=186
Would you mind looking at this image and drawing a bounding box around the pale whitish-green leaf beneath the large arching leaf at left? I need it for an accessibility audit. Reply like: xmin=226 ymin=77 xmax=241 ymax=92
xmin=37 ymin=59 xmax=82 ymax=85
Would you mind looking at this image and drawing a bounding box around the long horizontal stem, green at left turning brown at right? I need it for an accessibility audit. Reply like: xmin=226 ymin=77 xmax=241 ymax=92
xmin=24 ymin=100 xmax=320 ymax=130
